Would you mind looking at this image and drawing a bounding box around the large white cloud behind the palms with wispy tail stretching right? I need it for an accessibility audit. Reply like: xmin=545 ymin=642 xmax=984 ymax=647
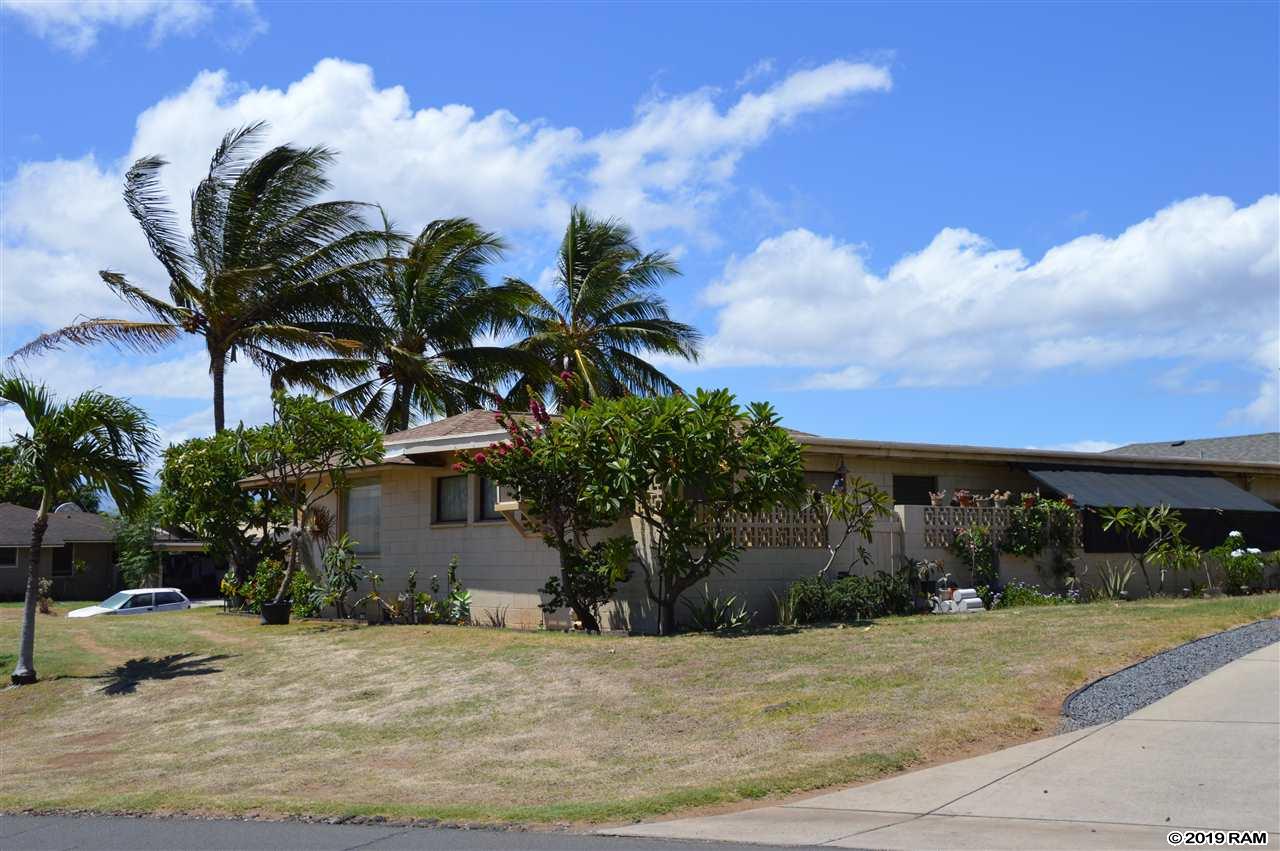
xmin=0 ymin=59 xmax=891 ymax=437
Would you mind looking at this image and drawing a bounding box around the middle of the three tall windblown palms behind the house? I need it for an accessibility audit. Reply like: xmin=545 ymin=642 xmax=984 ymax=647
xmin=271 ymin=219 xmax=530 ymax=434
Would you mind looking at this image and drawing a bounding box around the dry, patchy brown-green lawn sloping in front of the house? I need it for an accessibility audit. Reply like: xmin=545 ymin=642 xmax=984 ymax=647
xmin=0 ymin=595 xmax=1280 ymax=823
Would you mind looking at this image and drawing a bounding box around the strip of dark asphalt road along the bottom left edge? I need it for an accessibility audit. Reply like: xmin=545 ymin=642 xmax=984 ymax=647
xmin=0 ymin=815 xmax=819 ymax=851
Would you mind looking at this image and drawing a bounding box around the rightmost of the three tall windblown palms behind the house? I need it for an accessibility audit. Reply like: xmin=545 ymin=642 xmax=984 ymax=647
xmin=508 ymin=207 xmax=701 ymax=404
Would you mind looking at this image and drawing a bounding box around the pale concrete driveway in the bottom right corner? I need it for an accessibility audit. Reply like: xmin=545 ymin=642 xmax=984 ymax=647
xmin=603 ymin=644 xmax=1280 ymax=848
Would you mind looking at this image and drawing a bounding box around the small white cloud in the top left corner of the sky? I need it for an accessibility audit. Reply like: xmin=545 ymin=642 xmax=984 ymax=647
xmin=0 ymin=0 xmax=266 ymax=55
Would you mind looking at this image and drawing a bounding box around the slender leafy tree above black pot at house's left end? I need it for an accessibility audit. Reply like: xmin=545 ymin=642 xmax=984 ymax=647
xmin=237 ymin=392 xmax=383 ymax=611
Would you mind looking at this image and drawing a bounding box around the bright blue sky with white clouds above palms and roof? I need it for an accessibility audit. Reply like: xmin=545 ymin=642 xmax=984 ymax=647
xmin=0 ymin=1 xmax=1280 ymax=447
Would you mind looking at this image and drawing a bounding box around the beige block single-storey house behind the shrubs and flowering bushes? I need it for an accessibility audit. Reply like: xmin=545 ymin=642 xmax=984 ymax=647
xmin=262 ymin=411 xmax=1280 ymax=630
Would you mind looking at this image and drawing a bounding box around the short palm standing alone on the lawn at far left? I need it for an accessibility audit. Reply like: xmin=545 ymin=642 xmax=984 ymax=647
xmin=0 ymin=375 xmax=156 ymax=685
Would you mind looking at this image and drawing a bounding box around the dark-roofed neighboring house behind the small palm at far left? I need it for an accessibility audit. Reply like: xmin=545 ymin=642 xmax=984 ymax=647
xmin=0 ymin=503 xmax=115 ymax=600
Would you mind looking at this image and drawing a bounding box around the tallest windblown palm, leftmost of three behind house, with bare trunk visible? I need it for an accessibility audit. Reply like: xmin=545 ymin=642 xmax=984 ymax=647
xmin=13 ymin=123 xmax=383 ymax=431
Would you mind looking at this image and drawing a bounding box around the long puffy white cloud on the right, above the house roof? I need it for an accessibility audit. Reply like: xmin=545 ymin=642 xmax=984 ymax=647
xmin=703 ymin=196 xmax=1280 ymax=425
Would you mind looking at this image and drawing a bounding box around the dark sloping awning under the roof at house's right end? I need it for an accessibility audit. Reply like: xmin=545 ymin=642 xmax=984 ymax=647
xmin=1027 ymin=468 xmax=1280 ymax=512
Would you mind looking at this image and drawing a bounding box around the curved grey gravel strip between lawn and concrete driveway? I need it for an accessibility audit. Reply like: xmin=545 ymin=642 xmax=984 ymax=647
xmin=1062 ymin=618 xmax=1280 ymax=732
